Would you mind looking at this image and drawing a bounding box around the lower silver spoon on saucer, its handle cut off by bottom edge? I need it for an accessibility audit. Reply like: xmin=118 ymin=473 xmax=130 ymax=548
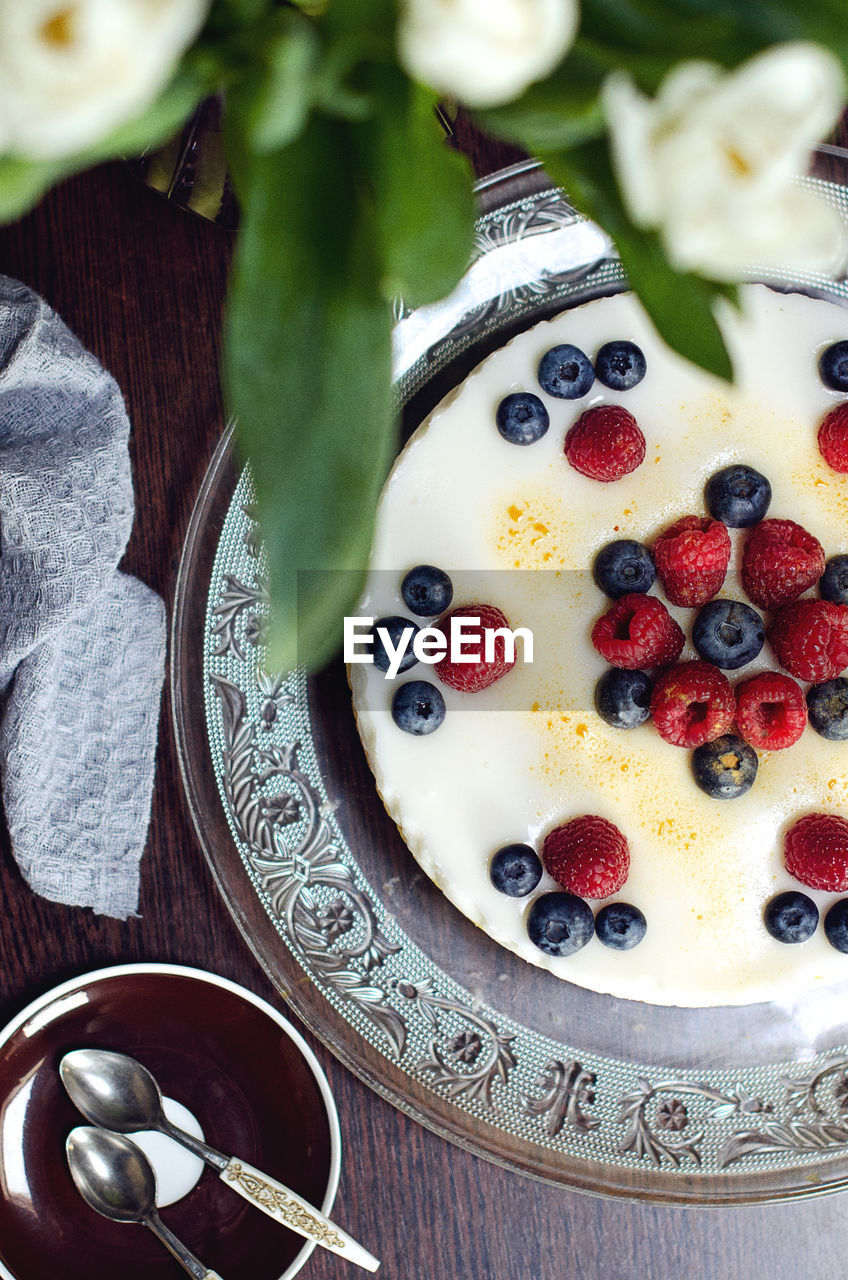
xmin=65 ymin=1125 xmax=220 ymax=1280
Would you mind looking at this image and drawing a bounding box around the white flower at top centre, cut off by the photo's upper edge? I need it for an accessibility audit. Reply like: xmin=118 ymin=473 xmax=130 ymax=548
xmin=398 ymin=0 xmax=578 ymax=106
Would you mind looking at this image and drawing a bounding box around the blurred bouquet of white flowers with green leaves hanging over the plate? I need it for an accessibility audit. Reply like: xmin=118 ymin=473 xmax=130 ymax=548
xmin=0 ymin=0 xmax=848 ymax=667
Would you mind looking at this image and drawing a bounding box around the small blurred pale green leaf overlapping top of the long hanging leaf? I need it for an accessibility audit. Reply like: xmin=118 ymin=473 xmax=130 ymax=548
xmin=243 ymin=9 xmax=319 ymax=151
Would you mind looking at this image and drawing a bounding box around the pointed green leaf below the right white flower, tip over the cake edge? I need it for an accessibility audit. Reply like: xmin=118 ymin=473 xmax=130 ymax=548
xmin=542 ymin=142 xmax=733 ymax=381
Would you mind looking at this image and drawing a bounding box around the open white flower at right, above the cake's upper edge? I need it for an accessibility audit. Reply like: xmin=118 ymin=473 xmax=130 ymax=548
xmin=603 ymin=44 xmax=845 ymax=280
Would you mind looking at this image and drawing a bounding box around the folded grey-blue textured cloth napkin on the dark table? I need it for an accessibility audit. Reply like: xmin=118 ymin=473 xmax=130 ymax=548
xmin=0 ymin=276 xmax=165 ymax=919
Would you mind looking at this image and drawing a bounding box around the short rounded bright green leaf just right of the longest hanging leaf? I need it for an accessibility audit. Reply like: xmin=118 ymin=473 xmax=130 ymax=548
xmin=368 ymin=70 xmax=474 ymax=306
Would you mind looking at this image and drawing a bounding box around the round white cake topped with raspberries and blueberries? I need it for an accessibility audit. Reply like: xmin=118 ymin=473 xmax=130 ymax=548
xmin=350 ymin=285 xmax=848 ymax=1006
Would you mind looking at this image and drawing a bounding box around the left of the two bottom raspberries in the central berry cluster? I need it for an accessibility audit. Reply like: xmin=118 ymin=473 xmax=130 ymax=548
xmin=651 ymin=662 xmax=737 ymax=746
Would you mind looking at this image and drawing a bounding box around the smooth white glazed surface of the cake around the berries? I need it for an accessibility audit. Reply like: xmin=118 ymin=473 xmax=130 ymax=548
xmin=350 ymin=285 xmax=848 ymax=1006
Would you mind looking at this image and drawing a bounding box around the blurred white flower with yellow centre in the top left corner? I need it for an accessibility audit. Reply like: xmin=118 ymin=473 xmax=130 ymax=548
xmin=0 ymin=0 xmax=210 ymax=159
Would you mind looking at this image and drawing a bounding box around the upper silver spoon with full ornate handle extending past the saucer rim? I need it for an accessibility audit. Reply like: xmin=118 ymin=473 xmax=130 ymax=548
xmin=59 ymin=1048 xmax=379 ymax=1271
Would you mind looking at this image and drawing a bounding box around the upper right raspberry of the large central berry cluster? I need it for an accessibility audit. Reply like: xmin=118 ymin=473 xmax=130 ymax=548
xmin=742 ymin=520 xmax=825 ymax=609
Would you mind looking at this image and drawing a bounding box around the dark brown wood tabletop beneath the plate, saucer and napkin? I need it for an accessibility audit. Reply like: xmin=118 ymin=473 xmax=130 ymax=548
xmin=0 ymin=140 xmax=848 ymax=1280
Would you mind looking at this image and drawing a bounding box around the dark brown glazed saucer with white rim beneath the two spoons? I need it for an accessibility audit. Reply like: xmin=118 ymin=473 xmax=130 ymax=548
xmin=0 ymin=964 xmax=341 ymax=1280
